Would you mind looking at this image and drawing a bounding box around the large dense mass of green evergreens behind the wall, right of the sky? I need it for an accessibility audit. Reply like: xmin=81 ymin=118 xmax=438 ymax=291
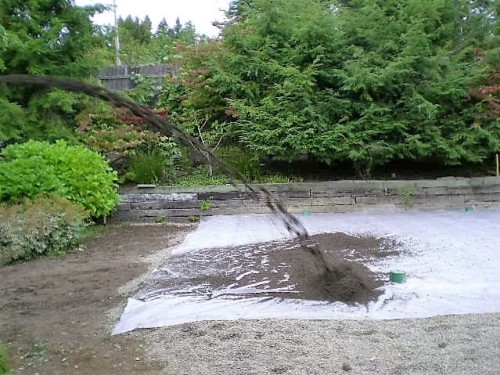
xmin=165 ymin=0 xmax=500 ymax=173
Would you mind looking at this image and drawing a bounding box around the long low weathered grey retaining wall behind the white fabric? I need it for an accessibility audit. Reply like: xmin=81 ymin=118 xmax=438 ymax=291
xmin=113 ymin=177 xmax=500 ymax=222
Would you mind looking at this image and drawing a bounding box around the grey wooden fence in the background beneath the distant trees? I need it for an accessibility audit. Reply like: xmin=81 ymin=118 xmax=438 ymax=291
xmin=99 ymin=64 xmax=173 ymax=91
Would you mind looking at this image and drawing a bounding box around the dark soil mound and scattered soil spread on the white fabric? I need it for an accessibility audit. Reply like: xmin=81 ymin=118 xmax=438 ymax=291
xmin=135 ymin=233 xmax=397 ymax=304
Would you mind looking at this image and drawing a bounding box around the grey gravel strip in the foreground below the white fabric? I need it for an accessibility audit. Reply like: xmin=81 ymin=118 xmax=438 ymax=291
xmin=130 ymin=314 xmax=500 ymax=375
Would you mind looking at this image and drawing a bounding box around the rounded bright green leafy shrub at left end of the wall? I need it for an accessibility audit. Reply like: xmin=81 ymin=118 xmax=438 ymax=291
xmin=0 ymin=141 xmax=119 ymax=217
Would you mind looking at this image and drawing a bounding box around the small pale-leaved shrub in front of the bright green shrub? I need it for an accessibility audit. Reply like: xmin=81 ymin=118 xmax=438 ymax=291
xmin=0 ymin=195 xmax=88 ymax=264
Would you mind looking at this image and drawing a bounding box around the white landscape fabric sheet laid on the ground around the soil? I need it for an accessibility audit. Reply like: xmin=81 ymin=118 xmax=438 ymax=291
xmin=113 ymin=210 xmax=500 ymax=334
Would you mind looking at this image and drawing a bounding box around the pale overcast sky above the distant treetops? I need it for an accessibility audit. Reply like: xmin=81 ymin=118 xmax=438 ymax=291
xmin=76 ymin=0 xmax=230 ymax=36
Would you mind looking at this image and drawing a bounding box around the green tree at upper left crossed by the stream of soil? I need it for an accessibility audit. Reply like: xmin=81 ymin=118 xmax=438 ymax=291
xmin=0 ymin=0 xmax=104 ymax=140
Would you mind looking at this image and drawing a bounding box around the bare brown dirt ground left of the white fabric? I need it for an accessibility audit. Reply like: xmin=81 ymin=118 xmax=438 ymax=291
xmin=0 ymin=226 xmax=191 ymax=375
